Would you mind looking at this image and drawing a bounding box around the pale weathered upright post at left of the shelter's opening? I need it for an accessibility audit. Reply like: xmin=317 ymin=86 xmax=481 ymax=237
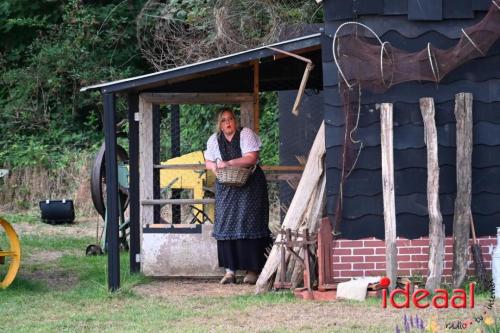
xmin=139 ymin=95 xmax=154 ymax=228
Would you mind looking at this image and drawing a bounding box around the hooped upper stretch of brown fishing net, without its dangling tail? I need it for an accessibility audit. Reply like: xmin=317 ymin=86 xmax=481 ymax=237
xmin=332 ymin=1 xmax=500 ymax=92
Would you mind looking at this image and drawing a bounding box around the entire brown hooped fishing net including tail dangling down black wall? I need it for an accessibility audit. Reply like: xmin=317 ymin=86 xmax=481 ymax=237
xmin=332 ymin=0 xmax=500 ymax=229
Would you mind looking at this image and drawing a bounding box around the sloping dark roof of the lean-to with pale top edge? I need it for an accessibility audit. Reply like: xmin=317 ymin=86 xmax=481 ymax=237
xmin=80 ymin=33 xmax=322 ymax=93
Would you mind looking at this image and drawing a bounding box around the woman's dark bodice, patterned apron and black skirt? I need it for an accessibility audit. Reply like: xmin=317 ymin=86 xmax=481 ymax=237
xmin=213 ymin=130 xmax=271 ymax=272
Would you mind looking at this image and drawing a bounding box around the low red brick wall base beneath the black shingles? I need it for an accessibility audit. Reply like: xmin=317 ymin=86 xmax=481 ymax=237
xmin=333 ymin=236 xmax=496 ymax=280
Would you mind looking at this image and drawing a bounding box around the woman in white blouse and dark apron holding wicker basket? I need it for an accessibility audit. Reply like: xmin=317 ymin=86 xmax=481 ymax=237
xmin=205 ymin=108 xmax=271 ymax=284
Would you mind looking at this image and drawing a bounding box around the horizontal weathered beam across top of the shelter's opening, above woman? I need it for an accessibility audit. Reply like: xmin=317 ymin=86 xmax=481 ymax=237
xmin=141 ymin=93 xmax=254 ymax=104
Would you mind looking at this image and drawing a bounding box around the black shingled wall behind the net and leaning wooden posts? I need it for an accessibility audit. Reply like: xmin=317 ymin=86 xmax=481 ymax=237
xmin=322 ymin=0 xmax=500 ymax=239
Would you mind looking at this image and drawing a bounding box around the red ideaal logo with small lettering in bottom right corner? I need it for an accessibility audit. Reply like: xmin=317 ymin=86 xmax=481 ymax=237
xmin=380 ymin=277 xmax=500 ymax=333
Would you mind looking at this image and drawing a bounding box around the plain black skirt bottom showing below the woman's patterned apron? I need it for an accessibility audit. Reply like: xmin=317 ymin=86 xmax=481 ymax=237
xmin=217 ymin=237 xmax=272 ymax=273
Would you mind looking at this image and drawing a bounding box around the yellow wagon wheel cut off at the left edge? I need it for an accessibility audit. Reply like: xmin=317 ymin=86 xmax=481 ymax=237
xmin=0 ymin=217 xmax=21 ymax=289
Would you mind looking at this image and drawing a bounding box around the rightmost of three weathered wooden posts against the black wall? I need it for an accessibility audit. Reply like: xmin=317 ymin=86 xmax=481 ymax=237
xmin=453 ymin=93 xmax=472 ymax=288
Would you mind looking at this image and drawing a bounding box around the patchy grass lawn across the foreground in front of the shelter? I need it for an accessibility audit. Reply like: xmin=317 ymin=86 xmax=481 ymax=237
xmin=0 ymin=214 xmax=500 ymax=333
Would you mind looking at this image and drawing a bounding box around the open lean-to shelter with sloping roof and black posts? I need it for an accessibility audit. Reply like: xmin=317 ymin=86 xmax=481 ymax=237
xmin=81 ymin=33 xmax=323 ymax=290
